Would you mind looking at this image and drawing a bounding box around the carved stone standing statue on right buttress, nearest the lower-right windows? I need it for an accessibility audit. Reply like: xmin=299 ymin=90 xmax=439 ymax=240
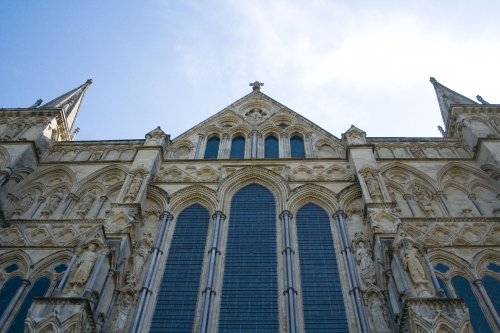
xmin=401 ymin=242 xmax=430 ymax=297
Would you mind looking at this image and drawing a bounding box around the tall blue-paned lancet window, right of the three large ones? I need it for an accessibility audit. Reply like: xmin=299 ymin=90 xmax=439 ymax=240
xmin=297 ymin=203 xmax=349 ymax=332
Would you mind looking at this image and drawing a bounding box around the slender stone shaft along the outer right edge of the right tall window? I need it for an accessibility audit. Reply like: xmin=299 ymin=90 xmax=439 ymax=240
xmin=334 ymin=210 xmax=369 ymax=332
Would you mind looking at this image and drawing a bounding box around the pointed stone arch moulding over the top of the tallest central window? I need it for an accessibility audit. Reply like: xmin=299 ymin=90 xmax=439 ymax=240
xmin=217 ymin=166 xmax=290 ymax=211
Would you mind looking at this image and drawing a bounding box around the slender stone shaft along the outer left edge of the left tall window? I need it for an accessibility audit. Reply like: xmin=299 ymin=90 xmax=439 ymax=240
xmin=130 ymin=212 xmax=173 ymax=332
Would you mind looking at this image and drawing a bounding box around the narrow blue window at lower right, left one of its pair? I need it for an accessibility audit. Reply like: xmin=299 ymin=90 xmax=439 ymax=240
xmin=451 ymin=276 xmax=492 ymax=333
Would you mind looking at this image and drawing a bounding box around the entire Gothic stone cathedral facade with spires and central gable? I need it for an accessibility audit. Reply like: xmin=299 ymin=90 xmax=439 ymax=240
xmin=0 ymin=78 xmax=500 ymax=333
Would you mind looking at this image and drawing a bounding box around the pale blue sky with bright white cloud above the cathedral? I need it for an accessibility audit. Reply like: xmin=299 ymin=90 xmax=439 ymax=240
xmin=0 ymin=0 xmax=500 ymax=140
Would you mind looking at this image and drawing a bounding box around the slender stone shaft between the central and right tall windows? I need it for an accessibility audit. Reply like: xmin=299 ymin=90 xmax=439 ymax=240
xmin=280 ymin=210 xmax=298 ymax=333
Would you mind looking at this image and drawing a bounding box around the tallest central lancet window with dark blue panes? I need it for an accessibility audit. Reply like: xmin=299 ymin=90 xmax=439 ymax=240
xmin=218 ymin=184 xmax=279 ymax=333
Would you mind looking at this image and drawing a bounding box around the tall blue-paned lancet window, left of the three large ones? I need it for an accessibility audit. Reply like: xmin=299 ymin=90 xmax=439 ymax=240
xmin=150 ymin=204 xmax=210 ymax=333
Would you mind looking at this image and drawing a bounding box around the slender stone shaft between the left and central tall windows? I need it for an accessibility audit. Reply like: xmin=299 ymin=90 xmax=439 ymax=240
xmin=200 ymin=211 xmax=226 ymax=333
